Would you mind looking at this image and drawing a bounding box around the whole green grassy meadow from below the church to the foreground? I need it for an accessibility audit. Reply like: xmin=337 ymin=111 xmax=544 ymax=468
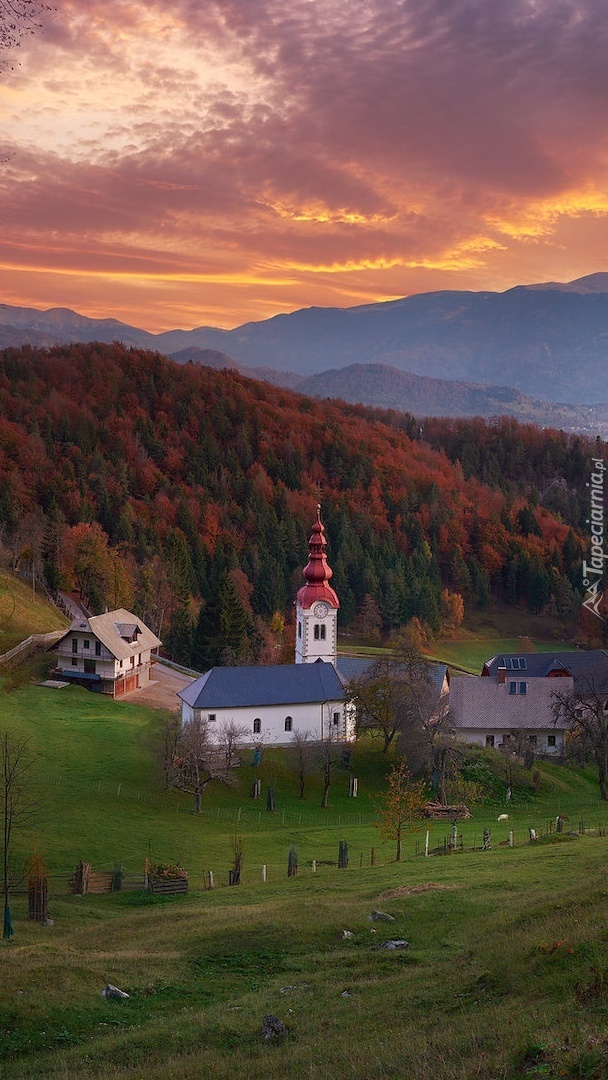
xmin=0 ymin=648 xmax=608 ymax=1080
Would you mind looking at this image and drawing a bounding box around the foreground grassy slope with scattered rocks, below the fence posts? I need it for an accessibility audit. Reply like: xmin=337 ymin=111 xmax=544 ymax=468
xmin=0 ymin=838 xmax=608 ymax=1080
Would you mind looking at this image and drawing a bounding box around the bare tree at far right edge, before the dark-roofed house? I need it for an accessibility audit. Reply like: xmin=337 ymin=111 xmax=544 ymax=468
xmin=553 ymin=679 xmax=608 ymax=802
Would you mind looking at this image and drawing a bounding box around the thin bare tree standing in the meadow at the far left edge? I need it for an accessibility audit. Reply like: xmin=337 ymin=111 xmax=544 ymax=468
xmin=0 ymin=730 xmax=38 ymax=939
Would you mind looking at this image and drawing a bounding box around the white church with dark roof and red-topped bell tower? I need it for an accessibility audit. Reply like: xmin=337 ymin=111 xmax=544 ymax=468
xmin=178 ymin=507 xmax=356 ymax=746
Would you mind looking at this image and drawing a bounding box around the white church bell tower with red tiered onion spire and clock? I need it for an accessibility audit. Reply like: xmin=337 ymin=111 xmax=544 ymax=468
xmin=296 ymin=507 xmax=340 ymax=664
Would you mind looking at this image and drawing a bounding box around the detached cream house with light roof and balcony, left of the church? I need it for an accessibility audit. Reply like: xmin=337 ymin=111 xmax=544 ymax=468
xmin=55 ymin=608 xmax=161 ymax=698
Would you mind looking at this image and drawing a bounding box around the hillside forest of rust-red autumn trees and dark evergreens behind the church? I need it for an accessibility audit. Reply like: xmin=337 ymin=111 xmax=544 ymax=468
xmin=0 ymin=345 xmax=603 ymax=667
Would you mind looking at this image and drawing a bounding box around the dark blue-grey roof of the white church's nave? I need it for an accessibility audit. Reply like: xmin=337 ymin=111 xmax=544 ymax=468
xmin=178 ymin=662 xmax=344 ymax=710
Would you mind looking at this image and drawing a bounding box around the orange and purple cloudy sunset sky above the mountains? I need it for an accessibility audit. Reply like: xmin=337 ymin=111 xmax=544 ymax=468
xmin=0 ymin=0 xmax=608 ymax=332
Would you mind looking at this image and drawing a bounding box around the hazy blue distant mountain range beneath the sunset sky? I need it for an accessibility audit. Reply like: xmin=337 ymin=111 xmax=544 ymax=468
xmin=0 ymin=273 xmax=608 ymax=434
